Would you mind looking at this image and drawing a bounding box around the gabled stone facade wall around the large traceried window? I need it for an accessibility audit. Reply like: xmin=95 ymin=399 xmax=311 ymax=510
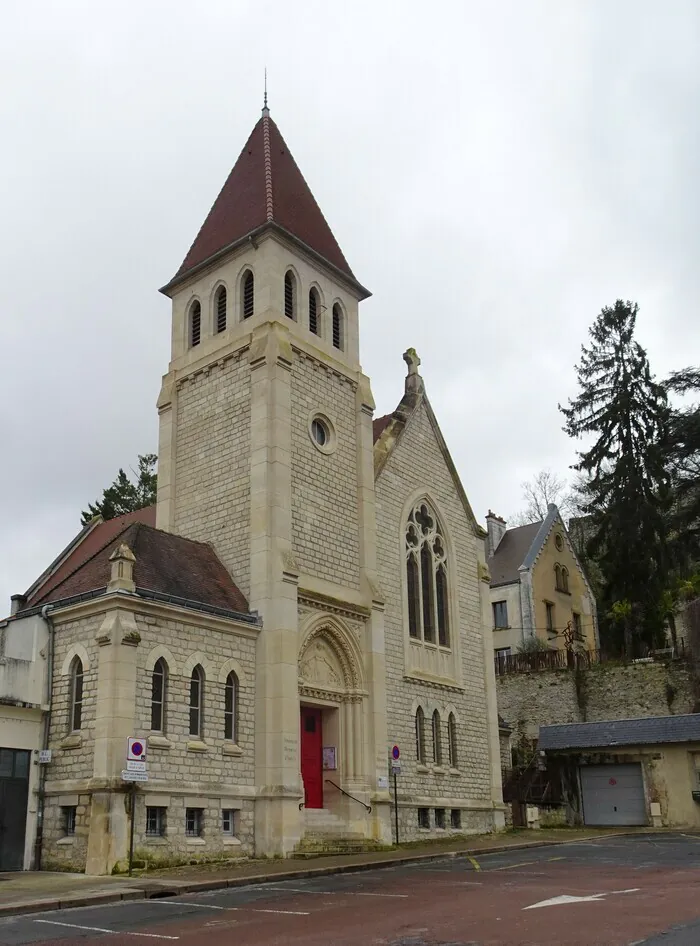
xmin=377 ymin=406 xmax=498 ymax=840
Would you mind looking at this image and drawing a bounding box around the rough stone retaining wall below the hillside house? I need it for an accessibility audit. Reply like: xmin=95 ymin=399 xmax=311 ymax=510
xmin=496 ymin=662 xmax=693 ymax=743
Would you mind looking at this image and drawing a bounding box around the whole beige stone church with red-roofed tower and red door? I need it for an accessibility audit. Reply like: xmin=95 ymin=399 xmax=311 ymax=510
xmin=6 ymin=101 xmax=504 ymax=873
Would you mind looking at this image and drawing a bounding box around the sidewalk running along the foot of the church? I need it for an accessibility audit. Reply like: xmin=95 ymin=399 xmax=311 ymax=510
xmin=0 ymin=828 xmax=650 ymax=916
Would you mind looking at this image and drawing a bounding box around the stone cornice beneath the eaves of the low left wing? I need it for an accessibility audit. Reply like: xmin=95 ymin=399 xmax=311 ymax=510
xmin=51 ymin=592 xmax=262 ymax=638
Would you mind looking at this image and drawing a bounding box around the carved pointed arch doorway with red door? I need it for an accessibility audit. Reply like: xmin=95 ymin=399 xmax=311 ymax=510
xmin=299 ymin=620 xmax=367 ymax=809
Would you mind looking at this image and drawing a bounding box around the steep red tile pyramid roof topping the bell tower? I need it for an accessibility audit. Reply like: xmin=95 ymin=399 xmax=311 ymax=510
xmin=172 ymin=112 xmax=355 ymax=282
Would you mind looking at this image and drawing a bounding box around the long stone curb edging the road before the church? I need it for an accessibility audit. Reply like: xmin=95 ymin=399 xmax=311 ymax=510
xmin=0 ymin=831 xmax=640 ymax=917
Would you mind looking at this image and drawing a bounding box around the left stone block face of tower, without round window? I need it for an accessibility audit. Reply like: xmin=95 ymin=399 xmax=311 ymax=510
xmin=171 ymin=352 xmax=251 ymax=596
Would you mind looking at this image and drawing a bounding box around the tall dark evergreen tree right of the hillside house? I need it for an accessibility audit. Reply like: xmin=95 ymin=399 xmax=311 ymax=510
xmin=559 ymin=299 xmax=669 ymax=656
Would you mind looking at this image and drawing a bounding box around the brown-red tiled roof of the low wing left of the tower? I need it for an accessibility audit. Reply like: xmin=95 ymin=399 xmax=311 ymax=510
xmin=20 ymin=507 xmax=248 ymax=614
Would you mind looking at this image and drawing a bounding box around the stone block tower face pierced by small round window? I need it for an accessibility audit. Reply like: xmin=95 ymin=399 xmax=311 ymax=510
xmin=291 ymin=350 xmax=360 ymax=588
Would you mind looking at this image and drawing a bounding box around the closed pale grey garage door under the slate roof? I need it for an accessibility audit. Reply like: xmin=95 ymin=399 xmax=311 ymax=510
xmin=579 ymin=762 xmax=647 ymax=825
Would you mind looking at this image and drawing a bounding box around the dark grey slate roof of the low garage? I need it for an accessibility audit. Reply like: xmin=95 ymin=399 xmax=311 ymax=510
xmin=538 ymin=713 xmax=700 ymax=750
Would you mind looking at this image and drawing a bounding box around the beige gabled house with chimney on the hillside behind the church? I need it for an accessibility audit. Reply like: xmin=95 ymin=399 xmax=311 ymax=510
xmin=486 ymin=504 xmax=598 ymax=657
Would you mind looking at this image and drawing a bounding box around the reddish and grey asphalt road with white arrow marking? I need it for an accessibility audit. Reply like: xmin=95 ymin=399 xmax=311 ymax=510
xmin=0 ymin=833 xmax=700 ymax=946
